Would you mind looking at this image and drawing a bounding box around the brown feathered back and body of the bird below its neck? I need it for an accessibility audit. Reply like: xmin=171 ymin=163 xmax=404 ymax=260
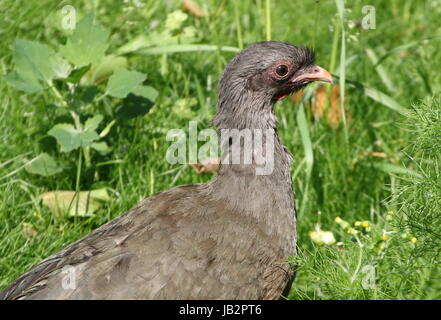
xmin=0 ymin=184 xmax=292 ymax=299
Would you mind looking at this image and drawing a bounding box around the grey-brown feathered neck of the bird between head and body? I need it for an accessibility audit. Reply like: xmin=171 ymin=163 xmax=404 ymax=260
xmin=211 ymin=97 xmax=295 ymax=238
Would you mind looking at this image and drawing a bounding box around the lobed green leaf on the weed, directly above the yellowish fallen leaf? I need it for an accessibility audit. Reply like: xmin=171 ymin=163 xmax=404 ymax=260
xmin=48 ymin=123 xmax=99 ymax=152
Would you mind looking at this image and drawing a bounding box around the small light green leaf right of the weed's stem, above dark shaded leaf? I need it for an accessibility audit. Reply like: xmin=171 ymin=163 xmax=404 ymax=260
xmin=106 ymin=69 xmax=147 ymax=99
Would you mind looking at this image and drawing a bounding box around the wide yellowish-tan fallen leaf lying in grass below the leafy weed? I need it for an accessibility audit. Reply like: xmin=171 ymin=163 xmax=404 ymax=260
xmin=40 ymin=188 xmax=110 ymax=217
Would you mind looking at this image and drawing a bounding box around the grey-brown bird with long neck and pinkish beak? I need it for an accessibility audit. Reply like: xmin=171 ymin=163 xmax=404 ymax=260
xmin=0 ymin=41 xmax=332 ymax=300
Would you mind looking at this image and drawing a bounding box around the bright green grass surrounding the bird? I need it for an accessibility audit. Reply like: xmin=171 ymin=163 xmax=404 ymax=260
xmin=0 ymin=0 xmax=441 ymax=299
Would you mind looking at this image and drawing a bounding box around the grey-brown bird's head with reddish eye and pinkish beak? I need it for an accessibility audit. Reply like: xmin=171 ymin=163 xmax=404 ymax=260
xmin=215 ymin=41 xmax=332 ymax=129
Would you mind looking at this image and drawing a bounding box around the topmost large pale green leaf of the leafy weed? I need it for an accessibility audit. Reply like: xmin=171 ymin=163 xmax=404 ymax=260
xmin=60 ymin=13 xmax=109 ymax=68
